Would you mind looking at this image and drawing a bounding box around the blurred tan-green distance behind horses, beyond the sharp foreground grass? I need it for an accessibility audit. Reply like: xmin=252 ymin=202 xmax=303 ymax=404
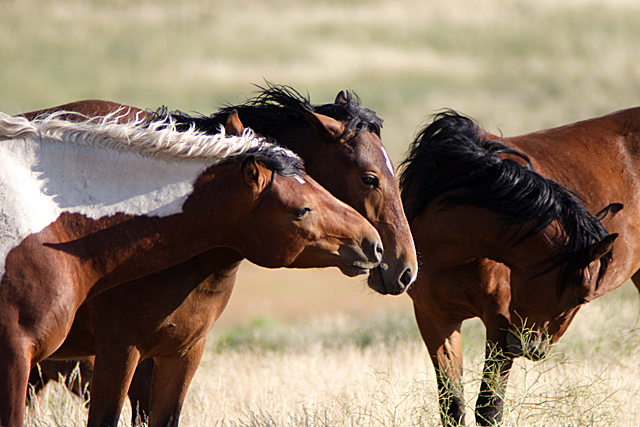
xmin=0 ymin=0 xmax=640 ymax=327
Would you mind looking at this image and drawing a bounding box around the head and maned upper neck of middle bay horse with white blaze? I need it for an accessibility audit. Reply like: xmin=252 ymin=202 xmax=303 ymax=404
xmin=172 ymin=84 xmax=418 ymax=294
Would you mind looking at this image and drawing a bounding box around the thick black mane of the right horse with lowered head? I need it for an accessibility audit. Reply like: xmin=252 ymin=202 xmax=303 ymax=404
xmin=400 ymin=111 xmax=611 ymax=292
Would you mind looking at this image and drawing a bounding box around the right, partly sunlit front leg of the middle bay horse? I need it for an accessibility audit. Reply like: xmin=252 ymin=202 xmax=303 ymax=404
xmin=149 ymin=338 xmax=206 ymax=427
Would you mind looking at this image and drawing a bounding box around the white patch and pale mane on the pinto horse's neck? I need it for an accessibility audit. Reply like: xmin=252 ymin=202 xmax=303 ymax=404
xmin=0 ymin=113 xmax=298 ymax=280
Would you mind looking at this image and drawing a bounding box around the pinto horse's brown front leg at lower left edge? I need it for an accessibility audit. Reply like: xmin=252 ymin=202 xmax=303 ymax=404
xmin=0 ymin=339 xmax=31 ymax=427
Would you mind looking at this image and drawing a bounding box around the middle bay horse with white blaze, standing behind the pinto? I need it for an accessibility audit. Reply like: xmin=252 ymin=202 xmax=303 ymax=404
xmin=23 ymin=86 xmax=417 ymax=425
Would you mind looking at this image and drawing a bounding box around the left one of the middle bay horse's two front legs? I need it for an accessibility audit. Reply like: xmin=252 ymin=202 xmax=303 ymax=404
xmin=87 ymin=347 xmax=140 ymax=427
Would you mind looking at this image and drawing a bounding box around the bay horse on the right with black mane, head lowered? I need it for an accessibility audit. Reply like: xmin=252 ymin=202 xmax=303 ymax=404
xmin=400 ymin=108 xmax=640 ymax=426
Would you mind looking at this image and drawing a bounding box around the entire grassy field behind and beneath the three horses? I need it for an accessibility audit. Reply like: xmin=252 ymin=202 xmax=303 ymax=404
xmin=0 ymin=0 xmax=640 ymax=427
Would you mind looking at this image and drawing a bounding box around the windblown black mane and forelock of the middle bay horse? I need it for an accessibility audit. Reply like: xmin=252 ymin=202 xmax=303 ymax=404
xmin=155 ymin=84 xmax=382 ymax=142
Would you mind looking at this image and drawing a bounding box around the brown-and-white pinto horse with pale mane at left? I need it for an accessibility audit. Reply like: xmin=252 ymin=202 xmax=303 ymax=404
xmin=0 ymin=113 xmax=382 ymax=427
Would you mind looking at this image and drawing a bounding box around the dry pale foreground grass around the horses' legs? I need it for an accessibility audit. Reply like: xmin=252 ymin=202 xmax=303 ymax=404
xmin=28 ymin=284 xmax=640 ymax=427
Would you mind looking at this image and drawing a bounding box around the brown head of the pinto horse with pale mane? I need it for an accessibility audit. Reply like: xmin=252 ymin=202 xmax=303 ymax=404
xmin=185 ymin=150 xmax=383 ymax=276
